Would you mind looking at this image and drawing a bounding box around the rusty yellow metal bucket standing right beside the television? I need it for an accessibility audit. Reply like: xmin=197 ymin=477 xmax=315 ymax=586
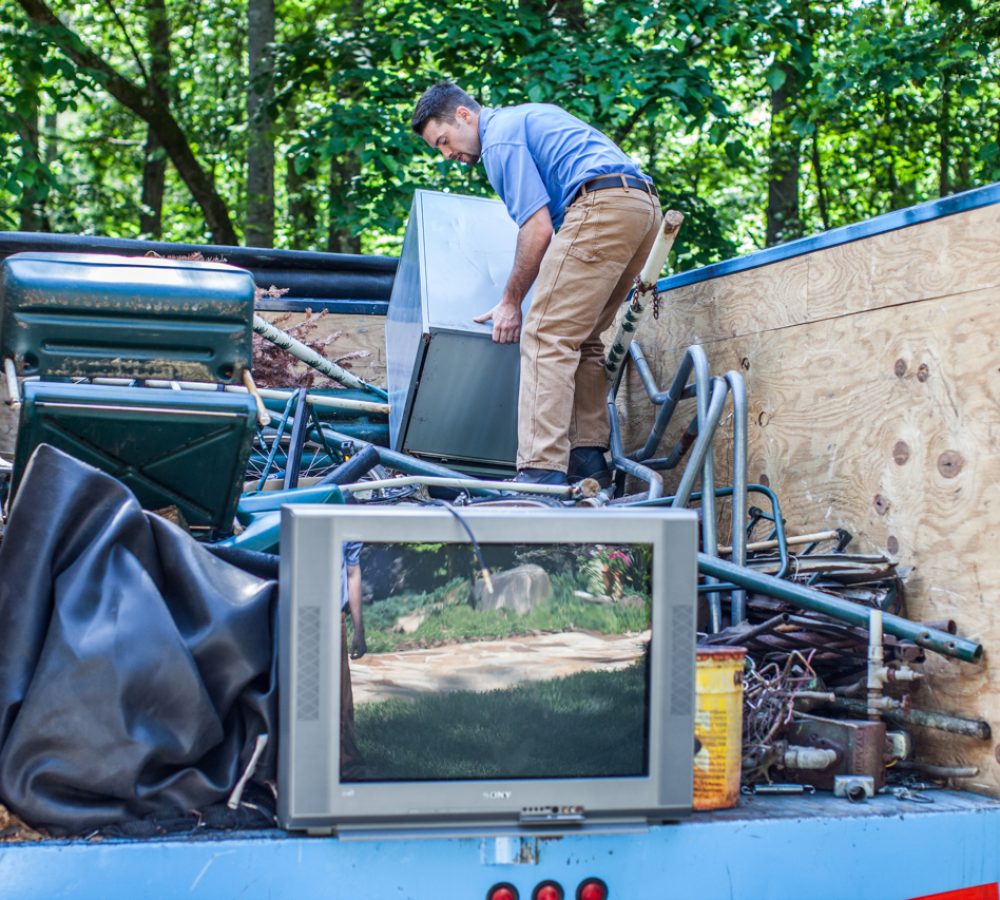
xmin=694 ymin=647 xmax=746 ymax=809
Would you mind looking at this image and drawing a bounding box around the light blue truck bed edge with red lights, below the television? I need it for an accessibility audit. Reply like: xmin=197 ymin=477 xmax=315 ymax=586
xmin=0 ymin=792 xmax=1000 ymax=900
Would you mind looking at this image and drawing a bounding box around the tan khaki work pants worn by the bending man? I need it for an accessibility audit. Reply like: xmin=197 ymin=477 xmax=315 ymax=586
xmin=517 ymin=187 xmax=662 ymax=472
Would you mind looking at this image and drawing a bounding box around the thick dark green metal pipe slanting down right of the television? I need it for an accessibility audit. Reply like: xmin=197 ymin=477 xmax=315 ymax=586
xmin=698 ymin=553 xmax=983 ymax=663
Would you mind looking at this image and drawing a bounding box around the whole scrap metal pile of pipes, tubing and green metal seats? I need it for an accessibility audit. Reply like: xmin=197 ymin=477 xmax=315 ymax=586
xmin=4 ymin=232 xmax=990 ymax=824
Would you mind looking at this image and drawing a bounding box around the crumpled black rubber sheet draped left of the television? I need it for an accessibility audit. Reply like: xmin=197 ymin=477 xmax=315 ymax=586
xmin=0 ymin=444 xmax=277 ymax=833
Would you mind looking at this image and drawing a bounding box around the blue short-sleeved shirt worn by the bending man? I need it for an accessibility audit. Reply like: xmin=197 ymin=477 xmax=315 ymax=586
xmin=479 ymin=103 xmax=642 ymax=228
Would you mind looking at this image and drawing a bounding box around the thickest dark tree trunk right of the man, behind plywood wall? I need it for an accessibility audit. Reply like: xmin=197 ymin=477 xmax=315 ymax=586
xmin=766 ymin=63 xmax=802 ymax=246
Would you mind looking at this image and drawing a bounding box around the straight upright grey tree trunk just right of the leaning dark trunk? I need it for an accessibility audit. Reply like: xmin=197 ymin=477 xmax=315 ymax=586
xmin=245 ymin=0 xmax=274 ymax=247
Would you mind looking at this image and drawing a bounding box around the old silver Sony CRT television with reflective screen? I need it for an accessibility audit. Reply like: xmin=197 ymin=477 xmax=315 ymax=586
xmin=278 ymin=505 xmax=697 ymax=834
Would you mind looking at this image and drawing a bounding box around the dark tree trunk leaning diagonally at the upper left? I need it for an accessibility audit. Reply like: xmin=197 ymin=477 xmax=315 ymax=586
xmin=17 ymin=0 xmax=237 ymax=244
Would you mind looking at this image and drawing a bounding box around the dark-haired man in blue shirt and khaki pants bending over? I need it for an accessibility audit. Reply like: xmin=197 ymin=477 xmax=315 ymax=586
xmin=412 ymin=82 xmax=662 ymax=484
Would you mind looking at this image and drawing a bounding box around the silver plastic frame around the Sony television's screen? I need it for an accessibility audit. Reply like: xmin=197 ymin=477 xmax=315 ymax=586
xmin=278 ymin=505 xmax=697 ymax=834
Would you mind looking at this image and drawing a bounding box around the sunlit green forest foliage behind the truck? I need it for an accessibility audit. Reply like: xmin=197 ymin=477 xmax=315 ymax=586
xmin=0 ymin=0 xmax=1000 ymax=260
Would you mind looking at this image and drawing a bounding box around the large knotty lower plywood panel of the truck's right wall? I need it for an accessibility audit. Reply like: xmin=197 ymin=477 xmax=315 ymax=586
xmin=621 ymin=278 xmax=1000 ymax=795
